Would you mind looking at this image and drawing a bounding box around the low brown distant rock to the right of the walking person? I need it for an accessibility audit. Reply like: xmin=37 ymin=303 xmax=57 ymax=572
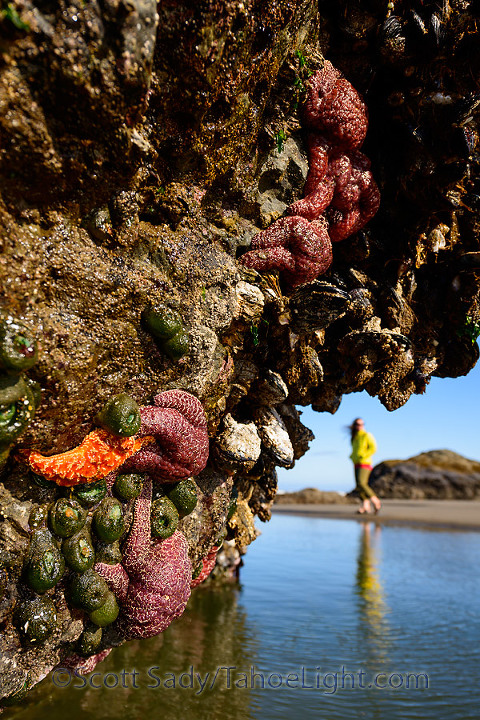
xmin=370 ymin=450 xmax=480 ymax=500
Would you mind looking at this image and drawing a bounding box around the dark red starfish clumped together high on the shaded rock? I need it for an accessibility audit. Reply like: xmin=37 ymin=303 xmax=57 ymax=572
xmin=240 ymin=60 xmax=380 ymax=288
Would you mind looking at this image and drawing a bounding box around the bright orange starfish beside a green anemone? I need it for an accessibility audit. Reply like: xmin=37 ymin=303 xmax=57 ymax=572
xmin=27 ymin=430 xmax=154 ymax=487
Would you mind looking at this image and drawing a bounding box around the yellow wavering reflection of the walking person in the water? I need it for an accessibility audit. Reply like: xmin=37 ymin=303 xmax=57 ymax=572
xmin=356 ymin=522 xmax=390 ymax=665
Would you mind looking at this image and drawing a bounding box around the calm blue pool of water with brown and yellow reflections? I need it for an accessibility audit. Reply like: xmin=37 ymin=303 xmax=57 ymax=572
xmin=3 ymin=515 xmax=480 ymax=720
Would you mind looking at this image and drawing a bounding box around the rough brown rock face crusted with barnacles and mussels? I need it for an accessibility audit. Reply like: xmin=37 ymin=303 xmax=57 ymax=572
xmin=0 ymin=0 xmax=480 ymax=699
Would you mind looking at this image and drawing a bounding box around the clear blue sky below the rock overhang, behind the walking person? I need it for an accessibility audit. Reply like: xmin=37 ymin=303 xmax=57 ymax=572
xmin=278 ymin=354 xmax=480 ymax=492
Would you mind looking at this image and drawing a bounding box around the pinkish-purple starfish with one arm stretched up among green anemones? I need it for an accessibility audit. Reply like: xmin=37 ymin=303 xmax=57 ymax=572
xmin=95 ymin=478 xmax=192 ymax=638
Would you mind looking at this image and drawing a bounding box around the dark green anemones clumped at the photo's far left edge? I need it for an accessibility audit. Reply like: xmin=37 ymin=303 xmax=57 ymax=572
xmin=0 ymin=315 xmax=40 ymax=467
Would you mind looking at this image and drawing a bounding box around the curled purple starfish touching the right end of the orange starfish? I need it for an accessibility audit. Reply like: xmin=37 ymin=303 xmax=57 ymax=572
xmin=122 ymin=390 xmax=209 ymax=483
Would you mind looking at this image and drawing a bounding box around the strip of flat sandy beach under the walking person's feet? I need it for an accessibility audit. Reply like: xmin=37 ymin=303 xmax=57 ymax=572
xmin=272 ymin=500 xmax=480 ymax=530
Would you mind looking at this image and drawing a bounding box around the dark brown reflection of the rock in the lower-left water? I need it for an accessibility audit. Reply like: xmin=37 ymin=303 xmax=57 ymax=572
xmin=2 ymin=586 xmax=256 ymax=720
